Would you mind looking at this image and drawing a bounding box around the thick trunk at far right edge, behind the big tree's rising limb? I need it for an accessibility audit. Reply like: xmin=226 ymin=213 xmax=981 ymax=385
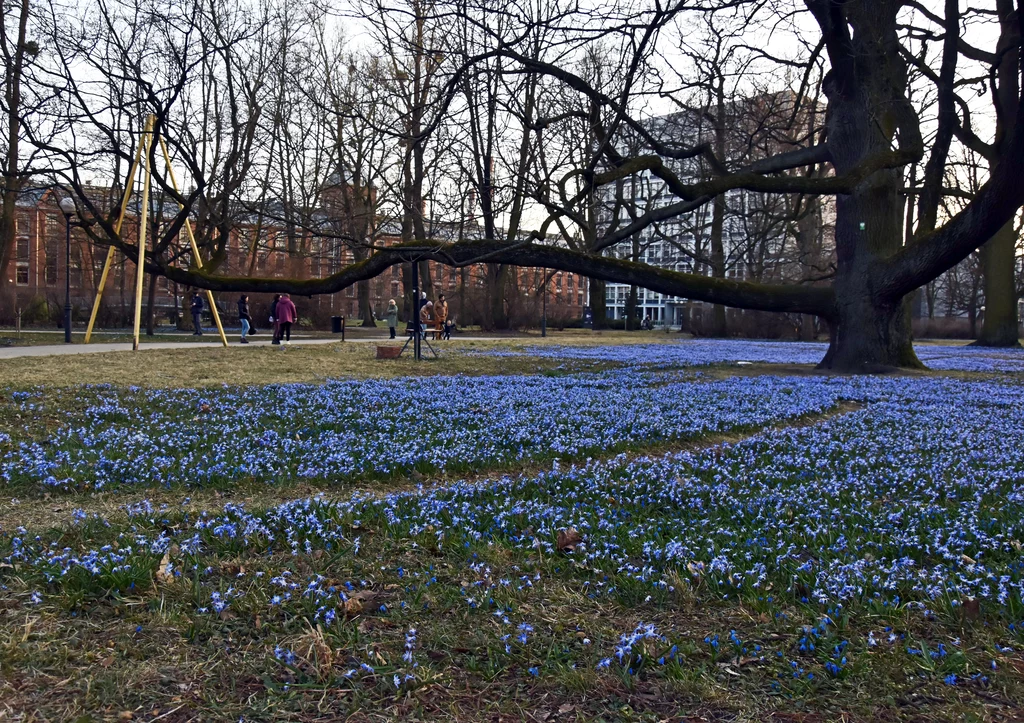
xmin=975 ymin=221 xmax=1020 ymax=346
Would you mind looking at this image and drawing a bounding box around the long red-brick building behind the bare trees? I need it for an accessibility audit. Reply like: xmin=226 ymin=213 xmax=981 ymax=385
xmin=0 ymin=187 xmax=588 ymax=328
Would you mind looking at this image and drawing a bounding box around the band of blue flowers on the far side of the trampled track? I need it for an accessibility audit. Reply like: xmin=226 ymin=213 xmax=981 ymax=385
xmin=0 ymin=370 xmax=843 ymax=491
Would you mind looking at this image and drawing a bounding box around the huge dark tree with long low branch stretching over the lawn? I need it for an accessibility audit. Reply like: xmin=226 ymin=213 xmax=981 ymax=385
xmin=44 ymin=0 xmax=1024 ymax=371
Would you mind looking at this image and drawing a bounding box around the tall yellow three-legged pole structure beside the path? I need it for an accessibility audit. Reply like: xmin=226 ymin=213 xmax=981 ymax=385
xmin=85 ymin=115 xmax=227 ymax=351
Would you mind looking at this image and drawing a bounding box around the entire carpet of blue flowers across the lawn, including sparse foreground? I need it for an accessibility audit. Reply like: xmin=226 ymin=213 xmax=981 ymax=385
xmin=0 ymin=342 xmax=1024 ymax=720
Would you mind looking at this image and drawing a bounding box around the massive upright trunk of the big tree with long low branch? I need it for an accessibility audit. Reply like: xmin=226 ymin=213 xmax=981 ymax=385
xmin=812 ymin=1 xmax=923 ymax=374
